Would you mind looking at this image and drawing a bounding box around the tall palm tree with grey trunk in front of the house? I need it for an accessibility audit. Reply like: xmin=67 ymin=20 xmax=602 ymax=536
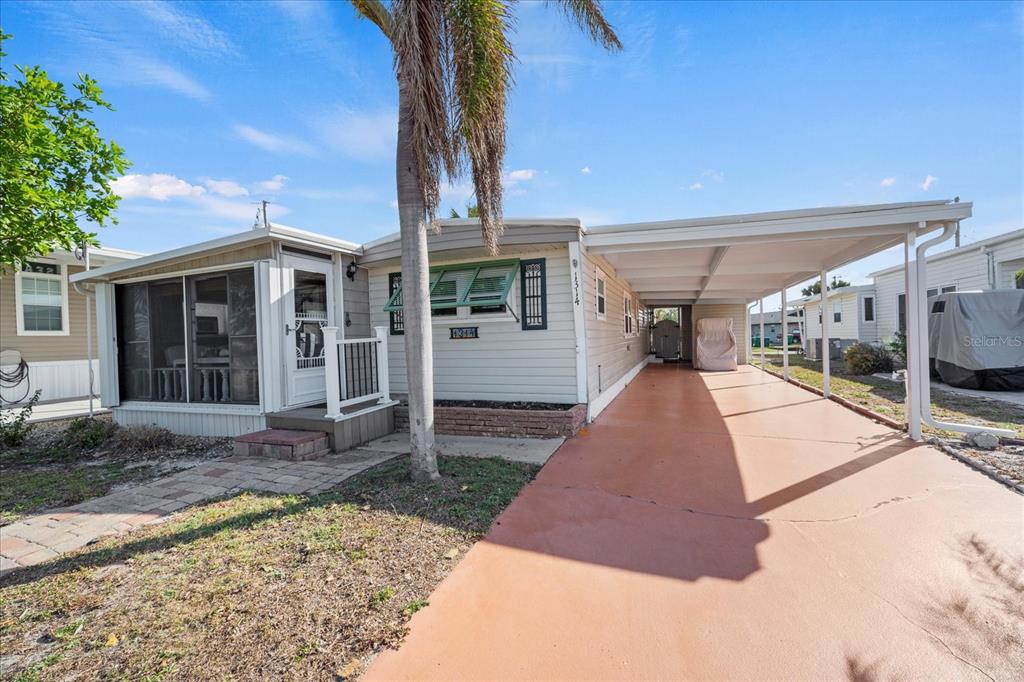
xmin=352 ymin=0 xmax=622 ymax=480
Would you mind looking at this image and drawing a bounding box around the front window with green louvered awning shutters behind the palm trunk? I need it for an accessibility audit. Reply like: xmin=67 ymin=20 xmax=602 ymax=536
xmin=384 ymin=260 xmax=519 ymax=323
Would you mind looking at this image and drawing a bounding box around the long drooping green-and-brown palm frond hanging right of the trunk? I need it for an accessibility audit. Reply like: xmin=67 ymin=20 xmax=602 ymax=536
xmin=444 ymin=0 xmax=515 ymax=254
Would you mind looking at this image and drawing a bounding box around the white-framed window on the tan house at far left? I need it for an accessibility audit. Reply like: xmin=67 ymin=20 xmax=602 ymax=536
xmin=14 ymin=261 xmax=70 ymax=336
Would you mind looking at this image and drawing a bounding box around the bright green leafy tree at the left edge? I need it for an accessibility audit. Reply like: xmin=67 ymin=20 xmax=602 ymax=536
xmin=0 ymin=31 xmax=129 ymax=266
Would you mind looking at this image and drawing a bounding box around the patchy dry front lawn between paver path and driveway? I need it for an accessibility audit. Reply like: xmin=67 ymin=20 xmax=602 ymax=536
xmin=0 ymin=458 xmax=538 ymax=680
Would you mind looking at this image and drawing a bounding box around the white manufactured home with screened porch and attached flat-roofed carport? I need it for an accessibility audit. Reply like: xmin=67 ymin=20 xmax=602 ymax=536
xmin=72 ymin=197 xmax=970 ymax=440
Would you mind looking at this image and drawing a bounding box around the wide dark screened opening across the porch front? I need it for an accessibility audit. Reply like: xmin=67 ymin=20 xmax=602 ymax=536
xmin=115 ymin=268 xmax=259 ymax=403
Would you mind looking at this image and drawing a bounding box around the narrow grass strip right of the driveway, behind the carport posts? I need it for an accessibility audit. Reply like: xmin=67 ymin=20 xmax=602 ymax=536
xmin=753 ymin=348 xmax=1024 ymax=438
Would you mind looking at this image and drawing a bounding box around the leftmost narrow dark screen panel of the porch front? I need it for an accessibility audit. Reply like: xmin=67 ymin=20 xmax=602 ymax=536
xmin=115 ymin=284 xmax=152 ymax=400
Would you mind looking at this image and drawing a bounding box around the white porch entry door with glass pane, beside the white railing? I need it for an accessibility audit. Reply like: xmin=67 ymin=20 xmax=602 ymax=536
xmin=283 ymin=254 xmax=334 ymax=408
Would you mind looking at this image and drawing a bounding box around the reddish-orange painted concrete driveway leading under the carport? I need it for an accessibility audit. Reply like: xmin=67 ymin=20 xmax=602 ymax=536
xmin=367 ymin=366 xmax=1024 ymax=680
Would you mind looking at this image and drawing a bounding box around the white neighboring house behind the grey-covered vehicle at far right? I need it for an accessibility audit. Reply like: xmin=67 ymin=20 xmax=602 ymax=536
xmin=871 ymin=229 xmax=1024 ymax=341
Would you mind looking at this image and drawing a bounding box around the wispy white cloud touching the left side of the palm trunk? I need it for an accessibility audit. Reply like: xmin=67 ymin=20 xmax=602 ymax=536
xmin=313 ymin=106 xmax=398 ymax=163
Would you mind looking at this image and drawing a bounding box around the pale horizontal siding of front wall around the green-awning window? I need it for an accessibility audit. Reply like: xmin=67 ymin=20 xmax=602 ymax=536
xmin=370 ymin=247 xmax=577 ymax=402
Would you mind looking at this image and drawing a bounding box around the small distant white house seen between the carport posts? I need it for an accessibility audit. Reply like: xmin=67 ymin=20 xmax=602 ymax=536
xmin=794 ymin=285 xmax=877 ymax=358
